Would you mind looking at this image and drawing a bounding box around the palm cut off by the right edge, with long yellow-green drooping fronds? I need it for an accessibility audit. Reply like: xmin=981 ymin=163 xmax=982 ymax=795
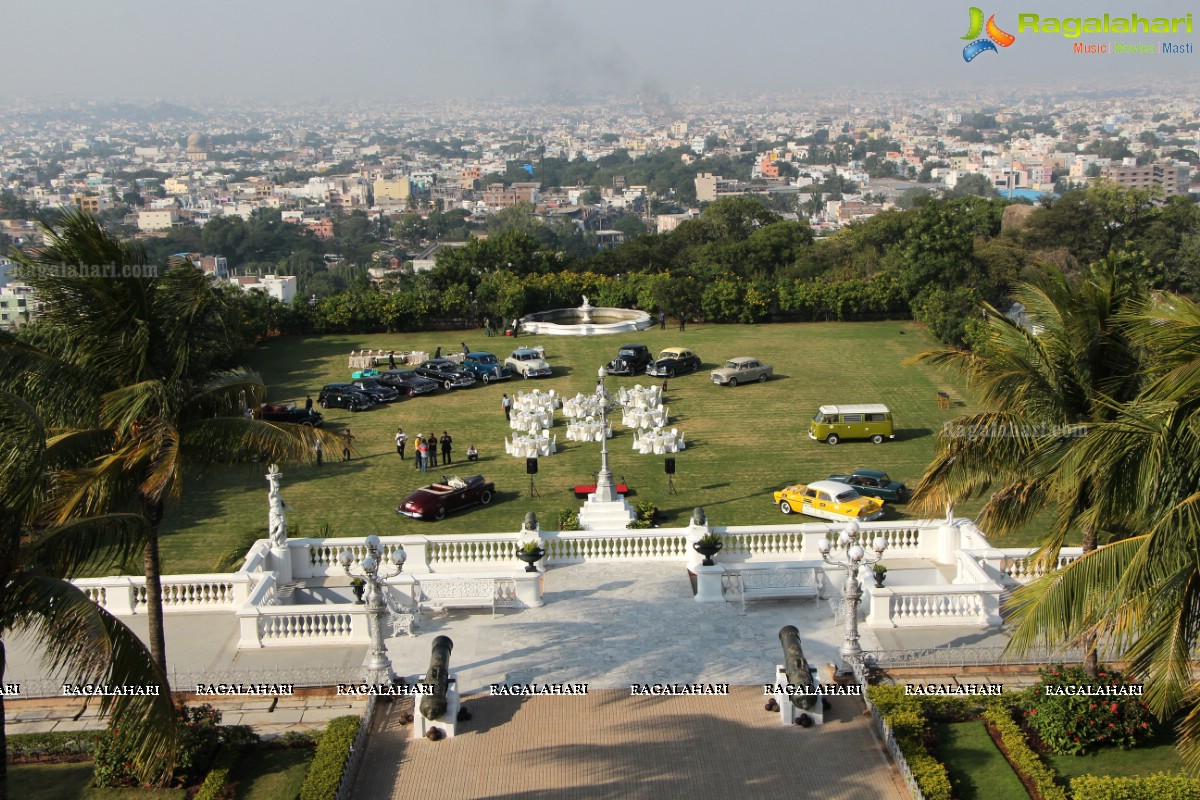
xmin=1013 ymin=295 xmax=1200 ymax=771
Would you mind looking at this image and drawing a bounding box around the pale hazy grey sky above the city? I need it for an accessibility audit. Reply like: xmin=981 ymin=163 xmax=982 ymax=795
xmin=2 ymin=0 xmax=1200 ymax=100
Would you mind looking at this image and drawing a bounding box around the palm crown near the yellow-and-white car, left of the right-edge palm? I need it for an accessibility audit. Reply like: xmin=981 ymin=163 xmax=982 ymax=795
xmin=908 ymin=260 xmax=1146 ymax=675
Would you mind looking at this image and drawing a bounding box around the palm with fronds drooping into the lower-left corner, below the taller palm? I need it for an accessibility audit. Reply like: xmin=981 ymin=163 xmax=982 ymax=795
xmin=0 ymin=392 xmax=178 ymax=800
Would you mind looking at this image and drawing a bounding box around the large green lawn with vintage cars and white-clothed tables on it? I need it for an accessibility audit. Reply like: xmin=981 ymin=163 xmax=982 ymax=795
xmin=150 ymin=321 xmax=1046 ymax=573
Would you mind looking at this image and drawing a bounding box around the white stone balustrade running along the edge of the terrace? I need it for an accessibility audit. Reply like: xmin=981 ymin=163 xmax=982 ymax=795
xmin=74 ymin=519 xmax=1079 ymax=648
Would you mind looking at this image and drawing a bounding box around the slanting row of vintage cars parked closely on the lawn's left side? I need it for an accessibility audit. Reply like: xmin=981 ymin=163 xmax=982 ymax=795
xmin=317 ymin=348 xmax=552 ymax=411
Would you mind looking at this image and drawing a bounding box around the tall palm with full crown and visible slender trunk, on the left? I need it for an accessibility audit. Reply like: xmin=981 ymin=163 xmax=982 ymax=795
xmin=0 ymin=212 xmax=335 ymax=673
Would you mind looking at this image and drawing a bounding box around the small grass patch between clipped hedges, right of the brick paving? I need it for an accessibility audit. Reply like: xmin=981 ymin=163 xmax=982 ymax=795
xmin=934 ymin=722 xmax=1030 ymax=800
